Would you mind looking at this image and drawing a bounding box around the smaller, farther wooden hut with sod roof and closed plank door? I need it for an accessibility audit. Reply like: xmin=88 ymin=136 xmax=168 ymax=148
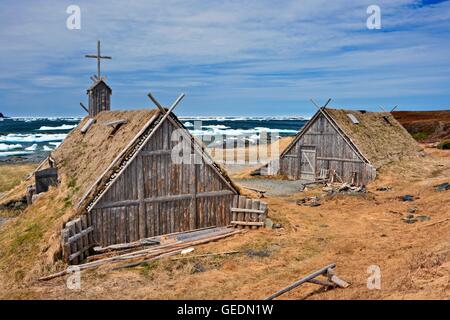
xmin=279 ymin=108 xmax=421 ymax=184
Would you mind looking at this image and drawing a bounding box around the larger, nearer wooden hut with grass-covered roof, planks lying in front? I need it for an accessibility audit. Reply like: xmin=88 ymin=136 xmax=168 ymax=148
xmin=43 ymin=104 xmax=267 ymax=263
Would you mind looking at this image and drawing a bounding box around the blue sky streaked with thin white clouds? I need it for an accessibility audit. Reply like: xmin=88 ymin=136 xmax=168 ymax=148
xmin=0 ymin=0 xmax=450 ymax=116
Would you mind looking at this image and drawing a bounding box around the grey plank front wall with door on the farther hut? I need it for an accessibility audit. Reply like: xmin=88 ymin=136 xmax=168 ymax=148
xmin=280 ymin=115 xmax=375 ymax=184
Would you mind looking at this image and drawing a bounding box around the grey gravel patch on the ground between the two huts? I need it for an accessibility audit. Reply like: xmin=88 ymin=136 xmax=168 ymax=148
xmin=233 ymin=179 xmax=301 ymax=196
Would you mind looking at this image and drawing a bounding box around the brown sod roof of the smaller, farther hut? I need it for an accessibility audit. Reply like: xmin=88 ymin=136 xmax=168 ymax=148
xmin=325 ymin=108 xmax=422 ymax=168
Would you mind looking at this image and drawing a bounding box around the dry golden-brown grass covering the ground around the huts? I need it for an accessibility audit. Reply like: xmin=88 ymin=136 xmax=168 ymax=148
xmin=0 ymin=145 xmax=450 ymax=299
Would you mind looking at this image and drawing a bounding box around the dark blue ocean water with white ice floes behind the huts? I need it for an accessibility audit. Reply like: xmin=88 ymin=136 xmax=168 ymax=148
xmin=0 ymin=117 xmax=307 ymax=162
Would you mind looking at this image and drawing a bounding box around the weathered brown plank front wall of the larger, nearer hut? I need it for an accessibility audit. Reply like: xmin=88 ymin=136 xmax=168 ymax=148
xmin=90 ymin=121 xmax=236 ymax=246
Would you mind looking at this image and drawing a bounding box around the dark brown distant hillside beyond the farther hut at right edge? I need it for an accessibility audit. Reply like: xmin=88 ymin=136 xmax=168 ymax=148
xmin=392 ymin=110 xmax=450 ymax=142
